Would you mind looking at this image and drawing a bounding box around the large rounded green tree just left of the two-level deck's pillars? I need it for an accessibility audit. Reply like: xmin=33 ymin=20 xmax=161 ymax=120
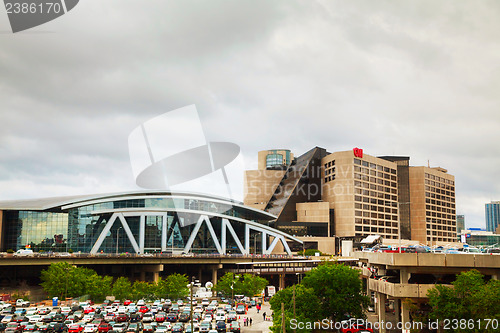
xmin=298 ymin=261 xmax=369 ymax=321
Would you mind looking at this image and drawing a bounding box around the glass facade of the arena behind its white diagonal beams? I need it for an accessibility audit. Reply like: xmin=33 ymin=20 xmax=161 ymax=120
xmin=3 ymin=195 xmax=276 ymax=253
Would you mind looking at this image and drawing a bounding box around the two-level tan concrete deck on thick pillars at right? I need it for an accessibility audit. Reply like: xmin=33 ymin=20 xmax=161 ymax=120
xmin=353 ymin=252 xmax=500 ymax=333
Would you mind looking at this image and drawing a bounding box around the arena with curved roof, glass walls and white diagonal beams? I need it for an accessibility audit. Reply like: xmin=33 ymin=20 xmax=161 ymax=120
xmin=0 ymin=191 xmax=302 ymax=255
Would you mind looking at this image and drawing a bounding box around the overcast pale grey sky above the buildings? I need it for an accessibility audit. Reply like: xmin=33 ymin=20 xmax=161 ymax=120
xmin=0 ymin=0 xmax=500 ymax=227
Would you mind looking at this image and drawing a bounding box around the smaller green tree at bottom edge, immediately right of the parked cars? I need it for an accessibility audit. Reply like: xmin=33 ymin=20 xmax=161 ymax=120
xmin=270 ymin=284 xmax=321 ymax=333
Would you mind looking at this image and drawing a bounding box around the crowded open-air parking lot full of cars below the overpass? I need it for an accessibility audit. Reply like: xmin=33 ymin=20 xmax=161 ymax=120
xmin=0 ymin=299 xmax=271 ymax=333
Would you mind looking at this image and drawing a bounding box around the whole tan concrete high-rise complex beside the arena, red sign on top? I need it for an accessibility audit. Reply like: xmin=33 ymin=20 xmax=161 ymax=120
xmin=244 ymin=147 xmax=456 ymax=249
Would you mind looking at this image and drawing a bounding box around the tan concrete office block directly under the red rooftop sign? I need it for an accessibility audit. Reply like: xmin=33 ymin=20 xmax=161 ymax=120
xmin=322 ymin=151 xmax=398 ymax=239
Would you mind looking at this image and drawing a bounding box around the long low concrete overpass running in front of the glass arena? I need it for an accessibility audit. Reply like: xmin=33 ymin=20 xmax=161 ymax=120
xmin=0 ymin=254 xmax=304 ymax=284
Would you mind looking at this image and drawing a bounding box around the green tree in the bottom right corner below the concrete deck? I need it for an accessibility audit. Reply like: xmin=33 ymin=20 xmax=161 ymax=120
xmin=427 ymin=269 xmax=500 ymax=332
